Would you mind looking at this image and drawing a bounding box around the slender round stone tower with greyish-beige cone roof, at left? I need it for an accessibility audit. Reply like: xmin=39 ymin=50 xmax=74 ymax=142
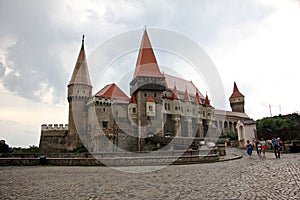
xmin=66 ymin=35 xmax=92 ymax=150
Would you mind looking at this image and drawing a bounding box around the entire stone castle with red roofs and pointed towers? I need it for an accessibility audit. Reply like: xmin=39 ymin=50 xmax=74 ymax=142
xmin=40 ymin=30 xmax=255 ymax=153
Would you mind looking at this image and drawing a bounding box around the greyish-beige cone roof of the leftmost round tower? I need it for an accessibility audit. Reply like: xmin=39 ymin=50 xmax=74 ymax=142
xmin=69 ymin=35 xmax=92 ymax=86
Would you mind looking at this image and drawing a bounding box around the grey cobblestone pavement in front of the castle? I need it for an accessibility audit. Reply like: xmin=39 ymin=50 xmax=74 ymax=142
xmin=0 ymin=149 xmax=300 ymax=199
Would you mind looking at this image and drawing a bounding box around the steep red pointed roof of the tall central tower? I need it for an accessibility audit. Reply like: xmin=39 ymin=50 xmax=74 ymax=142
xmin=133 ymin=28 xmax=164 ymax=79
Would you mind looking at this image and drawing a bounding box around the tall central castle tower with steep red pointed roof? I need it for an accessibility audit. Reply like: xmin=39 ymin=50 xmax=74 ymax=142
xmin=130 ymin=29 xmax=166 ymax=150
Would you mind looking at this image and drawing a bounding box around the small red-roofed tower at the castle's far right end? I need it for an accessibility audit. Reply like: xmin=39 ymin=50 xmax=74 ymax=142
xmin=229 ymin=82 xmax=245 ymax=113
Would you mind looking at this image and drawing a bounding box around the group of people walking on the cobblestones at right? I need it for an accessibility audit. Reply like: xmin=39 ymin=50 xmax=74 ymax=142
xmin=246 ymin=137 xmax=283 ymax=158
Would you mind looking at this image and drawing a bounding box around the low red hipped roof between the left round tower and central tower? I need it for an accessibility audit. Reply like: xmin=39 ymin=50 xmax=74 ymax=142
xmin=95 ymin=83 xmax=129 ymax=103
